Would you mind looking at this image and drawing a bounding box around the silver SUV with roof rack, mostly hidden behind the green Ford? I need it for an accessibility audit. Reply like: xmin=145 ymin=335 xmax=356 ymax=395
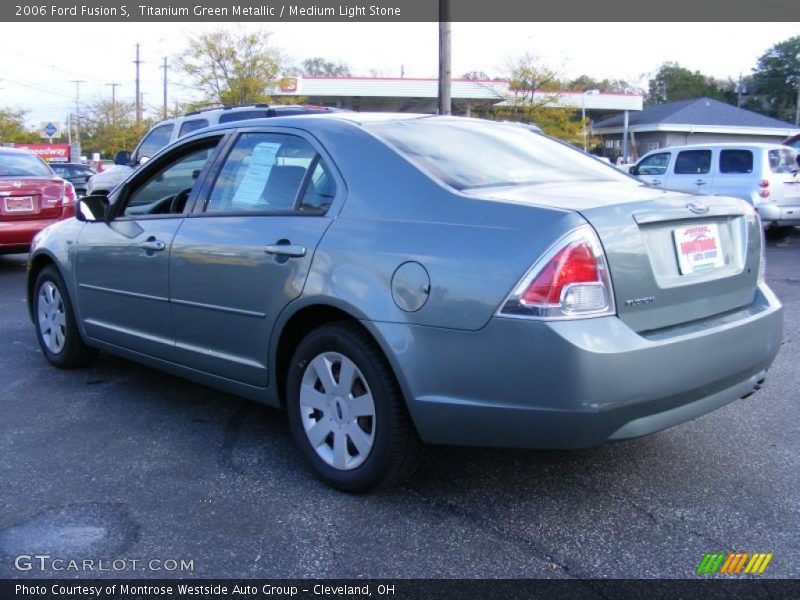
xmin=87 ymin=104 xmax=342 ymax=194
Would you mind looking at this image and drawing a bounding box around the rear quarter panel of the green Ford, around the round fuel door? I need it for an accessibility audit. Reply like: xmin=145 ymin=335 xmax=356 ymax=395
xmin=304 ymin=120 xmax=584 ymax=330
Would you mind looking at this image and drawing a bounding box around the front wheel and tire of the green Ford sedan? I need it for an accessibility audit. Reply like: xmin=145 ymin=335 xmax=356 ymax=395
xmin=33 ymin=266 xmax=97 ymax=369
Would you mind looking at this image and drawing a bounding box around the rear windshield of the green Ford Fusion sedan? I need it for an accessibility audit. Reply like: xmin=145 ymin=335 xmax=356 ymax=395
xmin=367 ymin=118 xmax=631 ymax=190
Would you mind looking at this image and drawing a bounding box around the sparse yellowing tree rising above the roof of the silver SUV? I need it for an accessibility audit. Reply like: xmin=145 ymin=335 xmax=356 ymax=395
xmin=177 ymin=29 xmax=285 ymax=105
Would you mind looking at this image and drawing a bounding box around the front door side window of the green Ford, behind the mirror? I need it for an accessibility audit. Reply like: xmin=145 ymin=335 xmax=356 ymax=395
xmin=118 ymin=138 xmax=219 ymax=217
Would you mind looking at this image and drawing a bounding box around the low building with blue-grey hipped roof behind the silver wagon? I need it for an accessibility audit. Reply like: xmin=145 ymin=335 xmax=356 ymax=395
xmin=592 ymin=98 xmax=800 ymax=160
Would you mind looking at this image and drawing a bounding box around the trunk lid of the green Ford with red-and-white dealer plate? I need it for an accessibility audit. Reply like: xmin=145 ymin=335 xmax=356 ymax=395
xmin=471 ymin=182 xmax=761 ymax=332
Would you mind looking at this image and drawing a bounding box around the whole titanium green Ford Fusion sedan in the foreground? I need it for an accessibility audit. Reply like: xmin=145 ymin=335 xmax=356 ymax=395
xmin=28 ymin=113 xmax=782 ymax=491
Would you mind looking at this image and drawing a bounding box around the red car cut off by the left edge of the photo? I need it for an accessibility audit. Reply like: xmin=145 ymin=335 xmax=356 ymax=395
xmin=0 ymin=148 xmax=75 ymax=254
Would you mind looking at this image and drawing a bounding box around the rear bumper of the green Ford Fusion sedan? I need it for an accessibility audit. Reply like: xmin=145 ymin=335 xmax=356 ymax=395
xmin=365 ymin=286 xmax=783 ymax=448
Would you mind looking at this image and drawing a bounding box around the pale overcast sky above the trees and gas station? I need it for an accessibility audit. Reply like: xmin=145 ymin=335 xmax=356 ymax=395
xmin=0 ymin=23 xmax=800 ymax=125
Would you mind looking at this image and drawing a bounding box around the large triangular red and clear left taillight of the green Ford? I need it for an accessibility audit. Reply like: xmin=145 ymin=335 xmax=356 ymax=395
xmin=498 ymin=225 xmax=615 ymax=319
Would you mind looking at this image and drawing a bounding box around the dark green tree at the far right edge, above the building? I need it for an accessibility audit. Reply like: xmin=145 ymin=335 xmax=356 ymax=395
xmin=753 ymin=36 xmax=800 ymax=121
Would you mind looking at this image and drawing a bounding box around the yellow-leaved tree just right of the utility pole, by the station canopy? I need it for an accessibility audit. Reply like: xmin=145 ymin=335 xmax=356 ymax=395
xmin=495 ymin=53 xmax=585 ymax=144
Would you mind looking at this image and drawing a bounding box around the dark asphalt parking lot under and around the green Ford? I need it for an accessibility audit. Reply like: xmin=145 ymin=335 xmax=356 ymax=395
xmin=0 ymin=231 xmax=800 ymax=578
